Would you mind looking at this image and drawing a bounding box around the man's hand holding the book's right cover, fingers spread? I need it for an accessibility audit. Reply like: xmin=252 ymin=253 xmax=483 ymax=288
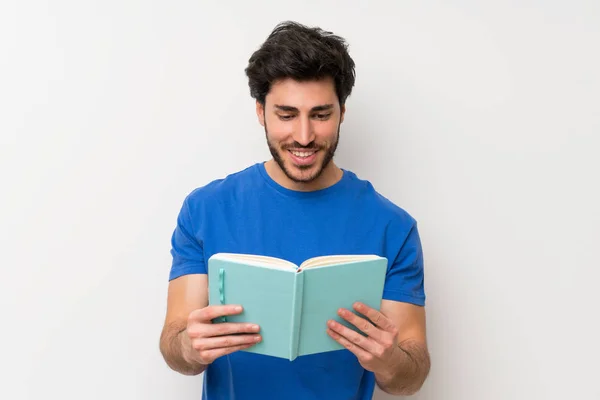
xmin=327 ymin=303 xmax=400 ymax=375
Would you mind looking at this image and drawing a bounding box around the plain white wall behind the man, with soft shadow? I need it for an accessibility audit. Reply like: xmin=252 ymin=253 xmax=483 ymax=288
xmin=0 ymin=0 xmax=600 ymax=400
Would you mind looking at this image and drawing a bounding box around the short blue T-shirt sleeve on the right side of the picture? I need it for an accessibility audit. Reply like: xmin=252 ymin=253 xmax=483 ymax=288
xmin=383 ymin=222 xmax=425 ymax=306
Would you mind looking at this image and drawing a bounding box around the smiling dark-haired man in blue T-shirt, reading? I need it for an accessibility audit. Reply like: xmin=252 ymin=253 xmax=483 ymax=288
xmin=160 ymin=22 xmax=429 ymax=400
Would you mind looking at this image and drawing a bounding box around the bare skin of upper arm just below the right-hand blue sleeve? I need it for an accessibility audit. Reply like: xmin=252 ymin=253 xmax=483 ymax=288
xmin=380 ymin=300 xmax=427 ymax=346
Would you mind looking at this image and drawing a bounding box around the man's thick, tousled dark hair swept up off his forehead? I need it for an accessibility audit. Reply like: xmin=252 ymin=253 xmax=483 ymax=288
xmin=246 ymin=21 xmax=355 ymax=105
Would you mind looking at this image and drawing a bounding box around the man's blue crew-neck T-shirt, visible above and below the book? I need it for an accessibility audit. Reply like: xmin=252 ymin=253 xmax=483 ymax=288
xmin=169 ymin=163 xmax=425 ymax=400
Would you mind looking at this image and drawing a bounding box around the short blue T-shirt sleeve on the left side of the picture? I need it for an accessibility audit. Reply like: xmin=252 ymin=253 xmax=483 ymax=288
xmin=169 ymin=197 xmax=206 ymax=280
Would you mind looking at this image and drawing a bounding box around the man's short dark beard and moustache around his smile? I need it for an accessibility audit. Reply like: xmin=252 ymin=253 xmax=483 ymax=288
xmin=265 ymin=120 xmax=341 ymax=183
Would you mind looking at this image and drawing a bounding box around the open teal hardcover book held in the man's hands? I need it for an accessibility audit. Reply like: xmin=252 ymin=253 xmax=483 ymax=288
xmin=208 ymin=253 xmax=387 ymax=361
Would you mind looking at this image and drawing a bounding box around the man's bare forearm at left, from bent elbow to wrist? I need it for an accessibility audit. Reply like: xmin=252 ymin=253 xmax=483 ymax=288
xmin=160 ymin=325 xmax=207 ymax=375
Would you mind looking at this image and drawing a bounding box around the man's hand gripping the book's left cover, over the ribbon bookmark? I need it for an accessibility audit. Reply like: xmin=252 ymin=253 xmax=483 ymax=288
xmin=184 ymin=305 xmax=262 ymax=365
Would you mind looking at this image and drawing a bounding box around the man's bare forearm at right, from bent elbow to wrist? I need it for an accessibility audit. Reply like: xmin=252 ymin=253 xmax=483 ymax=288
xmin=375 ymin=341 xmax=430 ymax=396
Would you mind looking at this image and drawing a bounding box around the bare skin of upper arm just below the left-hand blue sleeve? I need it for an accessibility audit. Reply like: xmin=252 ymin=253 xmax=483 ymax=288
xmin=164 ymin=274 xmax=208 ymax=331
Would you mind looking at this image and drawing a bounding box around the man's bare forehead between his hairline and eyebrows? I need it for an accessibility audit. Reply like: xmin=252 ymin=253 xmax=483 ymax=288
xmin=265 ymin=78 xmax=338 ymax=111
